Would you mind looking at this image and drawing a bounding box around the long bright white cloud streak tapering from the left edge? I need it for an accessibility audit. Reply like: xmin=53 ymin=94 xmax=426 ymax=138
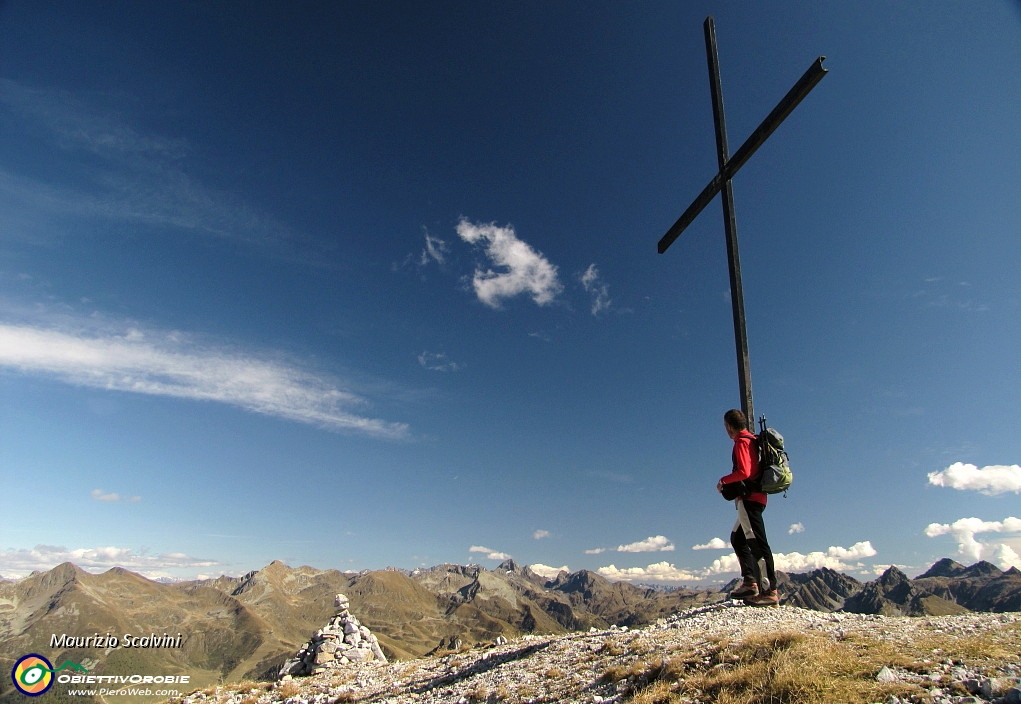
xmin=0 ymin=323 xmax=407 ymax=438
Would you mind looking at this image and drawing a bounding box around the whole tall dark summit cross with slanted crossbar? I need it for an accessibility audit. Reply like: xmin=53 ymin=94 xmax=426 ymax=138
xmin=659 ymin=17 xmax=826 ymax=430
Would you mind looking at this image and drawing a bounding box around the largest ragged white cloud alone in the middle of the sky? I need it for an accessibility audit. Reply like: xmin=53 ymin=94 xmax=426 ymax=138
xmin=457 ymin=219 xmax=563 ymax=308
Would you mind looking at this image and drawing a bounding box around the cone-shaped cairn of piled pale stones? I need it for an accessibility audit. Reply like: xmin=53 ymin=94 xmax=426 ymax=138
xmin=277 ymin=594 xmax=387 ymax=678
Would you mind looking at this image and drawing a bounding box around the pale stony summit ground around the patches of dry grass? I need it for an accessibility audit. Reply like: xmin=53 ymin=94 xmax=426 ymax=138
xmin=173 ymin=602 xmax=1021 ymax=704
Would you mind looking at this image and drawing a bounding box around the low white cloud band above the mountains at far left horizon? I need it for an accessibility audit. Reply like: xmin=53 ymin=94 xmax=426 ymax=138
xmin=0 ymin=545 xmax=223 ymax=579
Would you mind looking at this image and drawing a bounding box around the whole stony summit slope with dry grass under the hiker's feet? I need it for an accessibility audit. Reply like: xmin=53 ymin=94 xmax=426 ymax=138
xmin=183 ymin=602 xmax=1021 ymax=704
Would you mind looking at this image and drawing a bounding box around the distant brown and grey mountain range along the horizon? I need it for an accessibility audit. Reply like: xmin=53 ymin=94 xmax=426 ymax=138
xmin=0 ymin=558 xmax=1021 ymax=702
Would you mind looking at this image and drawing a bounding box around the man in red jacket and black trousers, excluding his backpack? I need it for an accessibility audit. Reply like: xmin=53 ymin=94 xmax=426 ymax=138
xmin=716 ymin=409 xmax=780 ymax=606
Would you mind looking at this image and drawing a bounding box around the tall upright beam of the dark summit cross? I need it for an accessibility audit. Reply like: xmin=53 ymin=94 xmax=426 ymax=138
xmin=702 ymin=17 xmax=756 ymax=431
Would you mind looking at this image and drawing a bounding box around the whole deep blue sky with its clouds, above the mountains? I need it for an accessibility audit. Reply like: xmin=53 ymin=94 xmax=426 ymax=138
xmin=0 ymin=0 xmax=1021 ymax=585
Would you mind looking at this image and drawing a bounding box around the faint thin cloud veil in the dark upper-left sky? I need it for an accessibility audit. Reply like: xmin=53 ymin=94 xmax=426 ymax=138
xmin=0 ymin=79 xmax=309 ymax=257
